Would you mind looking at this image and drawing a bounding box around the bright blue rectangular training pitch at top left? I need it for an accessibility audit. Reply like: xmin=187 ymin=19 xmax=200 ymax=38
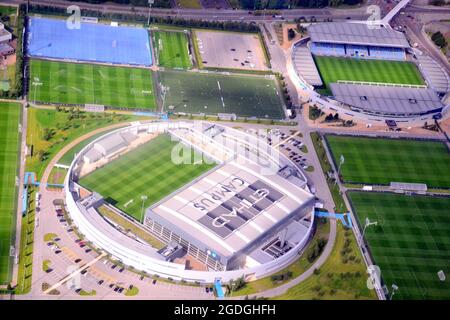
xmin=28 ymin=18 xmax=152 ymax=66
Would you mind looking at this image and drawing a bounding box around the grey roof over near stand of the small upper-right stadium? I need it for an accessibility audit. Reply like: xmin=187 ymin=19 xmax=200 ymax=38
xmin=330 ymin=83 xmax=444 ymax=115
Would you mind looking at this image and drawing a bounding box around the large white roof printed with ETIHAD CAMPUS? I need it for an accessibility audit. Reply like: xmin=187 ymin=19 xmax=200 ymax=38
xmin=147 ymin=157 xmax=314 ymax=259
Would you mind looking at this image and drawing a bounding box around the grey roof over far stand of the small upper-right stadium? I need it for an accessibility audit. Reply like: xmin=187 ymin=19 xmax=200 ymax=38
xmin=308 ymin=22 xmax=409 ymax=48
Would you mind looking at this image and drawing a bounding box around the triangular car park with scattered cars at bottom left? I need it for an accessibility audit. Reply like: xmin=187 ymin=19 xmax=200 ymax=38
xmin=25 ymin=189 xmax=215 ymax=299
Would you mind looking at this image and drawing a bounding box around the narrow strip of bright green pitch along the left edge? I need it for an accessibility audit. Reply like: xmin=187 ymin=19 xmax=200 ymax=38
xmin=0 ymin=102 xmax=20 ymax=284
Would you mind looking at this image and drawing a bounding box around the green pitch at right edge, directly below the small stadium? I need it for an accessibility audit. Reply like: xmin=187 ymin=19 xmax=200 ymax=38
xmin=326 ymin=135 xmax=450 ymax=188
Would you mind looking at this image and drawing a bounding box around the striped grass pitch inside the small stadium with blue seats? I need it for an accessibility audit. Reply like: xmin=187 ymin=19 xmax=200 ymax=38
xmin=314 ymin=56 xmax=424 ymax=93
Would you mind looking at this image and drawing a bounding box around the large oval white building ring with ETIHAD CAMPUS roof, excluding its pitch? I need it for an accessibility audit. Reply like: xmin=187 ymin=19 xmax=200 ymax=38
xmin=65 ymin=122 xmax=314 ymax=283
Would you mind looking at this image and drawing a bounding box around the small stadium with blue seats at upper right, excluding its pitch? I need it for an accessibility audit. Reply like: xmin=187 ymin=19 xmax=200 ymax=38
xmin=292 ymin=22 xmax=450 ymax=121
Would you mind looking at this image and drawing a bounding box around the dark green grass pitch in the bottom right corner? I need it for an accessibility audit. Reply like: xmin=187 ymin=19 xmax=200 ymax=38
xmin=350 ymin=192 xmax=450 ymax=300
